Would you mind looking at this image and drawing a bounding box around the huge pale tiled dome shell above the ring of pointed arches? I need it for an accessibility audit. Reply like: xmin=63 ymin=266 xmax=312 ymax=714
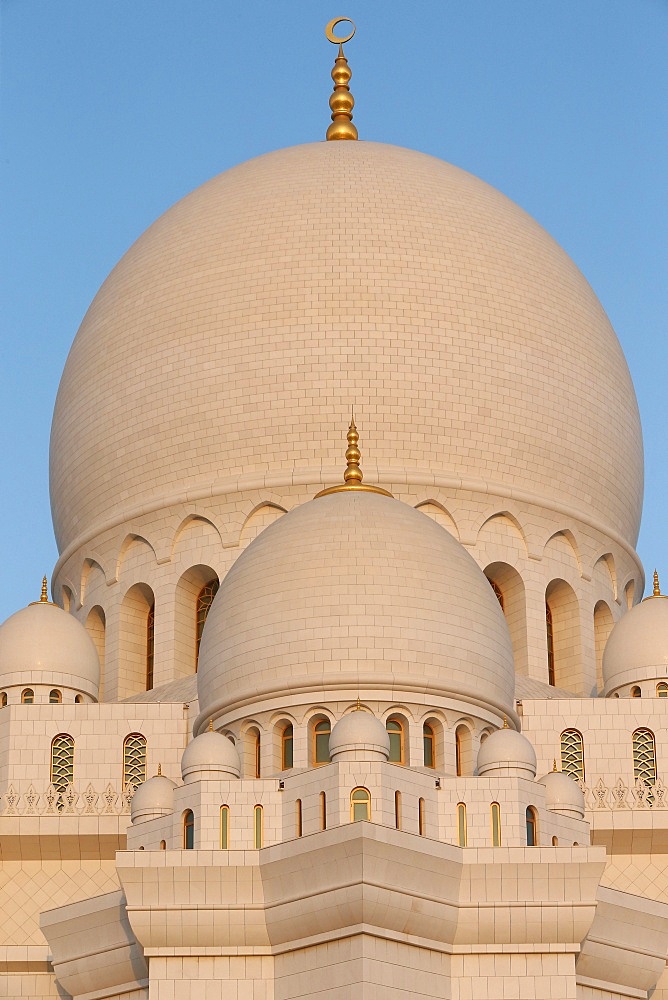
xmin=51 ymin=142 xmax=642 ymax=564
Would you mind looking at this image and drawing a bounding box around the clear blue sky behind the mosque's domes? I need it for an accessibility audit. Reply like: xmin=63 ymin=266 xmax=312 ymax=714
xmin=0 ymin=0 xmax=668 ymax=620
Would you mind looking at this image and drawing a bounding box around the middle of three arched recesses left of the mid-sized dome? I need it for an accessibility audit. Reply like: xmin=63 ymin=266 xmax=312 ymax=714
xmin=118 ymin=583 xmax=155 ymax=698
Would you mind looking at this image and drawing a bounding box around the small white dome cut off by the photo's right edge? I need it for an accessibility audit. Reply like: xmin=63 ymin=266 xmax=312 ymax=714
xmin=603 ymin=587 xmax=668 ymax=697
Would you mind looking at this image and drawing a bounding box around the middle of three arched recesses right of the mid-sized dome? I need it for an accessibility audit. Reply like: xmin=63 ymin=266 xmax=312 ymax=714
xmin=545 ymin=580 xmax=582 ymax=692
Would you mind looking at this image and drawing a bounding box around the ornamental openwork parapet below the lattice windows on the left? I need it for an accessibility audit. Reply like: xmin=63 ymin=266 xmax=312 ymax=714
xmin=0 ymin=782 xmax=134 ymax=819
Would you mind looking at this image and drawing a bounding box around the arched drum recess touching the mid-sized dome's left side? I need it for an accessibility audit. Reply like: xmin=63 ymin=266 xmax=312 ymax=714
xmin=174 ymin=565 xmax=219 ymax=677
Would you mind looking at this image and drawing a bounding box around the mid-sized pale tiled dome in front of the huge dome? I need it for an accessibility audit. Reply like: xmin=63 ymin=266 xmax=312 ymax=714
xmin=195 ymin=492 xmax=515 ymax=732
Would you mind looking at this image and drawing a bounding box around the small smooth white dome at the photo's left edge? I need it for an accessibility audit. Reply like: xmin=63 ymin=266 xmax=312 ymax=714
xmin=0 ymin=594 xmax=100 ymax=701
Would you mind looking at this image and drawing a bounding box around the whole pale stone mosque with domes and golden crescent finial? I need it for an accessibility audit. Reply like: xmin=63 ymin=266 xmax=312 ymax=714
xmin=0 ymin=18 xmax=668 ymax=1000
